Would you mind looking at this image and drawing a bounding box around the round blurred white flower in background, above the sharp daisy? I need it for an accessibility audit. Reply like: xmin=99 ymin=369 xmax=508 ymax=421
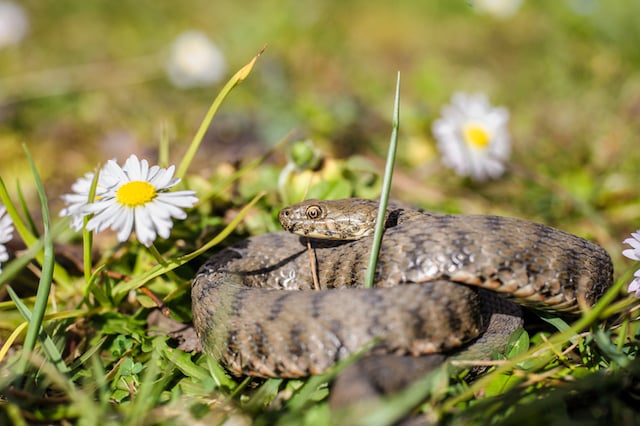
xmin=166 ymin=31 xmax=227 ymax=88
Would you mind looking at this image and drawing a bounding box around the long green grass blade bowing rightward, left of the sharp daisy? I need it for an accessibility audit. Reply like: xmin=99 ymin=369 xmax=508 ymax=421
xmin=17 ymin=146 xmax=54 ymax=376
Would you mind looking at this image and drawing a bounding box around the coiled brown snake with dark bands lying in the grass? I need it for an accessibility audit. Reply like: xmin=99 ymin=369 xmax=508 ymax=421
xmin=191 ymin=198 xmax=613 ymax=398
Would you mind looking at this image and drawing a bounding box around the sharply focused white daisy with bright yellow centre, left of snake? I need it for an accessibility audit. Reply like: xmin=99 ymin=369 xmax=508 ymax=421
xmin=82 ymin=155 xmax=198 ymax=247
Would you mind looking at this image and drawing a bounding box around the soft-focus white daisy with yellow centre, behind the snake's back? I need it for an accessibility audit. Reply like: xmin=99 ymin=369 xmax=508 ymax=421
xmin=432 ymin=93 xmax=511 ymax=181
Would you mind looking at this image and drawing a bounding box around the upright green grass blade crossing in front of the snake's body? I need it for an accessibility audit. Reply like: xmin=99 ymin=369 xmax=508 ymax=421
xmin=364 ymin=72 xmax=400 ymax=288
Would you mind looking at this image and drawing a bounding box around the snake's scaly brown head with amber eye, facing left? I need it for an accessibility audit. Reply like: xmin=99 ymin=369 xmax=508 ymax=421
xmin=278 ymin=198 xmax=378 ymax=240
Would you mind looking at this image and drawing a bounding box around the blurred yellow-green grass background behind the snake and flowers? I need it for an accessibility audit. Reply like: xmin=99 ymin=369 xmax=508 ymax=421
xmin=0 ymin=0 xmax=640 ymax=257
